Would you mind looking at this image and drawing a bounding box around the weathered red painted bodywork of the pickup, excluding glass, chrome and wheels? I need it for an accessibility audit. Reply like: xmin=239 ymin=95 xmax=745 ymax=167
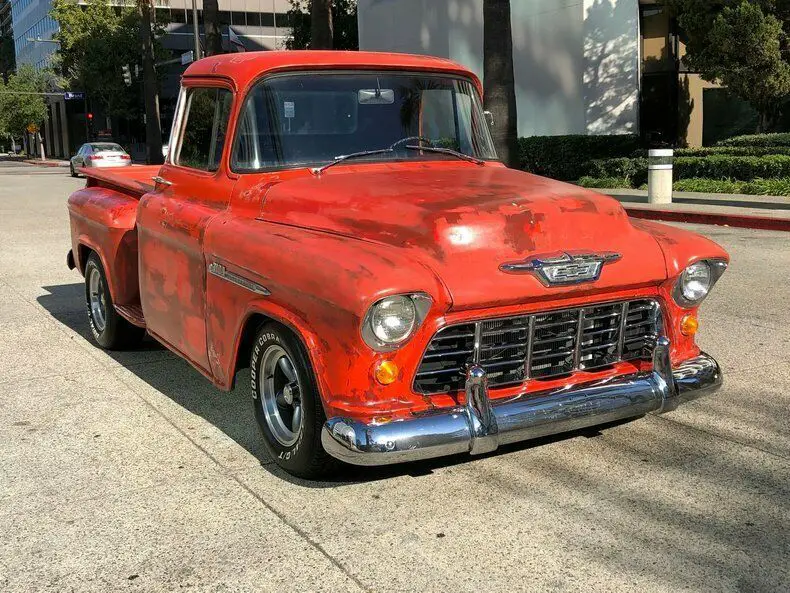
xmin=69 ymin=52 xmax=727 ymax=420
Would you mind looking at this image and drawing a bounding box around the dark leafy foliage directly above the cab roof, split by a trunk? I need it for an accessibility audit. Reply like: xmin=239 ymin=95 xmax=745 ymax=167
xmin=285 ymin=0 xmax=359 ymax=50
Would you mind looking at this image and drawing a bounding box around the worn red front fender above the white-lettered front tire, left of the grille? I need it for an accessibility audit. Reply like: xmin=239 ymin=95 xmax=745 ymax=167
xmin=205 ymin=216 xmax=450 ymax=415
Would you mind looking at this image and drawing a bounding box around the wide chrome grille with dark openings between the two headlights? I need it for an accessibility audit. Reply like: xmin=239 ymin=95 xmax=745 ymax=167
xmin=414 ymin=299 xmax=661 ymax=393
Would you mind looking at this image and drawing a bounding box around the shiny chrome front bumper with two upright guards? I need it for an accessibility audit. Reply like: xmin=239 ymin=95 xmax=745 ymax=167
xmin=321 ymin=338 xmax=722 ymax=465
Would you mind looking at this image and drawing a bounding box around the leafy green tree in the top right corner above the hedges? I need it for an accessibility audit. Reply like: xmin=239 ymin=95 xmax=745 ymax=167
xmin=672 ymin=0 xmax=790 ymax=132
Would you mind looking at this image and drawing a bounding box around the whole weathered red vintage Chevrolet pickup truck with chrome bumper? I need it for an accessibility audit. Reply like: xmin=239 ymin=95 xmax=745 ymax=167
xmin=67 ymin=52 xmax=728 ymax=476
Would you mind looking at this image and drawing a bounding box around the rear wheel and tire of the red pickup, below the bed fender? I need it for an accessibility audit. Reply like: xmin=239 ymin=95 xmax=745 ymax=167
xmin=85 ymin=253 xmax=145 ymax=350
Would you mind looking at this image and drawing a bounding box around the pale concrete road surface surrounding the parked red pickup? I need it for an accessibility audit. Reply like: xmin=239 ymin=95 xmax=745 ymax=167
xmin=0 ymin=163 xmax=790 ymax=592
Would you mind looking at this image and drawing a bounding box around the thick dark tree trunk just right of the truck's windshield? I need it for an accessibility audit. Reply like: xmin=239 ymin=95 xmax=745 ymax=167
xmin=483 ymin=0 xmax=520 ymax=168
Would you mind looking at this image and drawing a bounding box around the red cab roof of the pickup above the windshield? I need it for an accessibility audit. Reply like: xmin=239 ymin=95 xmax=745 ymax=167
xmin=184 ymin=50 xmax=482 ymax=94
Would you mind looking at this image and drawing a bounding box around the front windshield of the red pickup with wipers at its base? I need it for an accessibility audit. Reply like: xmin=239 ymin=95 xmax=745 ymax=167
xmin=231 ymin=72 xmax=496 ymax=172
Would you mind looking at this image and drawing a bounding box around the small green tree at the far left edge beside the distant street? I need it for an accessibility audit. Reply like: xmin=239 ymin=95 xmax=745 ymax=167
xmin=0 ymin=65 xmax=55 ymax=150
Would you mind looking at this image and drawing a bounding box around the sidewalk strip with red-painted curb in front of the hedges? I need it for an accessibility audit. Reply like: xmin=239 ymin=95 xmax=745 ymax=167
xmin=594 ymin=189 xmax=790 ymax=231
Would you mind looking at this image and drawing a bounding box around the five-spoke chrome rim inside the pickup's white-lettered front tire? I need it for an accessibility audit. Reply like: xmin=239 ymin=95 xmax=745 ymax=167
xmin=260 ymin=345 xmax=302 ymax=447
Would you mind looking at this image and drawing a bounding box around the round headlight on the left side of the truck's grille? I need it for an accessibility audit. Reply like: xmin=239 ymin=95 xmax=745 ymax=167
xmin=362 ymin=293 xmax=431 ymax=351
